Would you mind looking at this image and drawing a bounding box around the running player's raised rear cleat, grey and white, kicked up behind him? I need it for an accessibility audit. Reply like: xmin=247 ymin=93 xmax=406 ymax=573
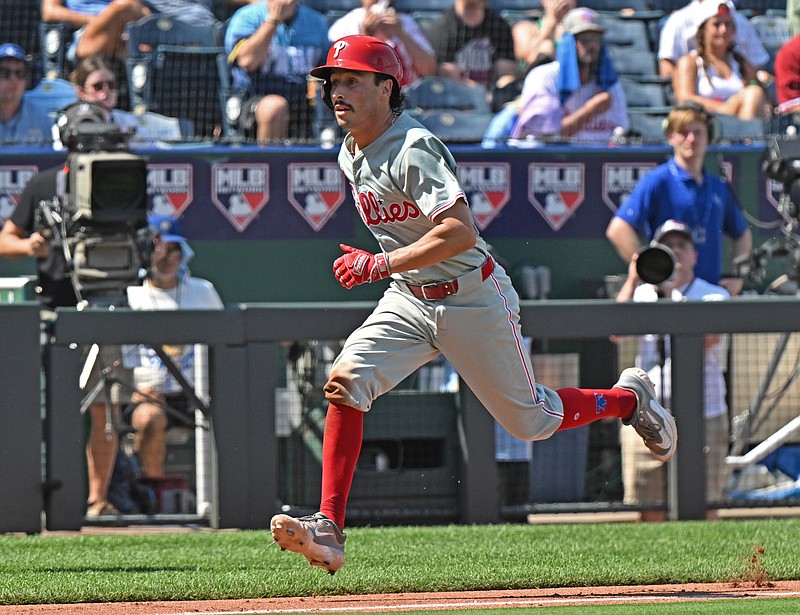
xmin=614 ymin=367 xmax=678 ymax=461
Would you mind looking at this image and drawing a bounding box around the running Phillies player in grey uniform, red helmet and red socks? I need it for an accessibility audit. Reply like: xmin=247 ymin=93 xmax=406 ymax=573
xmin=270 ymin=35 xmax=678 ymax=574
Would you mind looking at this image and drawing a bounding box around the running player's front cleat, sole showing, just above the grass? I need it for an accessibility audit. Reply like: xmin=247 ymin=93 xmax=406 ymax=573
xmin=269 ymin=513 xmax=347 ymax=574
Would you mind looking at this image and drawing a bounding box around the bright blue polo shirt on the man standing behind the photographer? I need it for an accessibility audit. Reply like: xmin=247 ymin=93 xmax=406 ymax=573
xmin=616 ymin=158 xmax=748 ymax=283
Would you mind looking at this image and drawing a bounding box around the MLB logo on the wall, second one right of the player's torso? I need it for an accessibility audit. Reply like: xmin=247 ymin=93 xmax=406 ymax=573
xmin=528 ymin=162 xmax=585 ymax=231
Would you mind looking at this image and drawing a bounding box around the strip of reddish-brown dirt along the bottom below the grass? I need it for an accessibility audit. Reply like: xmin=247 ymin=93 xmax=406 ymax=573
xmin=0 ymin=581 xmax=800 ymax=615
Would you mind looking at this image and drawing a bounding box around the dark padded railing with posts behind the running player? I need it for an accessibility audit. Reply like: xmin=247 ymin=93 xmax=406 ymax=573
xmin=0 ymin=296 xmax=800 ymax=533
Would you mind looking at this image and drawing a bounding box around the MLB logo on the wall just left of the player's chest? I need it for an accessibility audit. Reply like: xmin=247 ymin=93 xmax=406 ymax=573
xmin=286 ymin=162 xmax=345 ymax=231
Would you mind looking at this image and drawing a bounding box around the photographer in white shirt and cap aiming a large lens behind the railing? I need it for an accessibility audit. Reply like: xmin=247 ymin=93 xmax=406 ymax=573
xmin=617 ymin=220 xmax=730 ymax=521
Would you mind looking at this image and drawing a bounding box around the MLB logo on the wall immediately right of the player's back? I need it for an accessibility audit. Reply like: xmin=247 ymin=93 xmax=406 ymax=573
xmin=458 ymin=162 xmax=511 ymax=231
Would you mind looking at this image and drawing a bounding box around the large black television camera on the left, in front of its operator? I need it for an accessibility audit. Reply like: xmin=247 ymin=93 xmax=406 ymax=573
xmin=38 ymin=103 xmax=153 ymax=307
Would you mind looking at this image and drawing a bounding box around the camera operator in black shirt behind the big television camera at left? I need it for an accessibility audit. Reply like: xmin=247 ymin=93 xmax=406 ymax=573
xmin=0 ymin=103 xmax=135 ymax=517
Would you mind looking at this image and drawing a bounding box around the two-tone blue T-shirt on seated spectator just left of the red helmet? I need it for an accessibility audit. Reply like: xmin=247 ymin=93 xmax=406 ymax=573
xmin=225 ymin=2 xmax=330 ymax=95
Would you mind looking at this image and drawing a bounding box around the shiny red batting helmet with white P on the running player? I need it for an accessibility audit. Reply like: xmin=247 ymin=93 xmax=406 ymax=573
xmin=311 ymin=34 xmax=403 ymax=83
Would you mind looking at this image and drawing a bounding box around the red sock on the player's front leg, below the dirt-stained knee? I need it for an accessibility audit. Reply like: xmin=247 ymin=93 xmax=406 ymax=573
xmin=319 ymin=403 xmax=364 ymax=529
